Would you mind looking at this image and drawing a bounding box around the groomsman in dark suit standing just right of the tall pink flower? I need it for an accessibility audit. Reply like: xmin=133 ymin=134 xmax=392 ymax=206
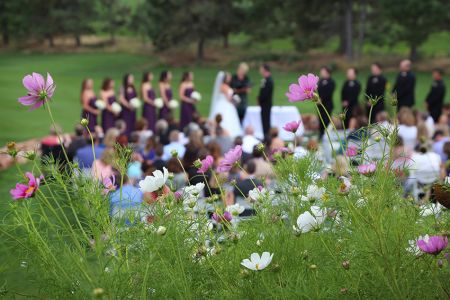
xmin=317 ymin=67 xmax=336 ymax=137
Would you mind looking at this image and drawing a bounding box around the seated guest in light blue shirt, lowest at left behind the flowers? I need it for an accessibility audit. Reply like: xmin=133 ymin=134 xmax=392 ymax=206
xmin=109 ymin=171 xmax=143 ymax=223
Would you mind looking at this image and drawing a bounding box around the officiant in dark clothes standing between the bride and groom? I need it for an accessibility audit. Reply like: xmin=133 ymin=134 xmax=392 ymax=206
xmin=230 ymin=62 xmax=251 ymax=124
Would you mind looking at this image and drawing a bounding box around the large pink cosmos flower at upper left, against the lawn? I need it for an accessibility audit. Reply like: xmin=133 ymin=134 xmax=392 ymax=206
xmin=19 ymin=73 xmax=56 ymax=110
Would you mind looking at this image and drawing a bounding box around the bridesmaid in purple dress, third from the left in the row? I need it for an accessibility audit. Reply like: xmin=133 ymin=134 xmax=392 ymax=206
xmin=120 ymin=74 xmax=137 ymax=137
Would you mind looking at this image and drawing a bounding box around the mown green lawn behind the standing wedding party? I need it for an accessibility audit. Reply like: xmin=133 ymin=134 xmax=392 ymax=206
xmin=0 ymin=53 xmax=450 ymax=144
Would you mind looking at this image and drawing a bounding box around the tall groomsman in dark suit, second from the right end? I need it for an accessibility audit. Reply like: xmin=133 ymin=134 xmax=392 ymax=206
xmin=392 ymin=59 xmax=416 ymax=110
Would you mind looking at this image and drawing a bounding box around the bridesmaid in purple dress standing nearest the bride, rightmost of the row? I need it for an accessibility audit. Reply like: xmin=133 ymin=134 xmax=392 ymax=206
xmin=179 ymin=72 xmax=197 ymax=130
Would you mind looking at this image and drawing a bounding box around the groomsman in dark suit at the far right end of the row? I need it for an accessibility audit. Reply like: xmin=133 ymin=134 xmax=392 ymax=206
xmin=425 ymin=69 xmax=445 ymax=123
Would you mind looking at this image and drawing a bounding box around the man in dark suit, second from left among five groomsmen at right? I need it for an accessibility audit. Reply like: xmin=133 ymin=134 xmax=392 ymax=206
xmin=341 ymin=68 xmax=361 ymax=128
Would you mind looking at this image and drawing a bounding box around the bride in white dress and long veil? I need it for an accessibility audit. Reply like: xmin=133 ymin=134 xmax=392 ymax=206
xmin=209 ymin=71 xmax=243 ymax=137
